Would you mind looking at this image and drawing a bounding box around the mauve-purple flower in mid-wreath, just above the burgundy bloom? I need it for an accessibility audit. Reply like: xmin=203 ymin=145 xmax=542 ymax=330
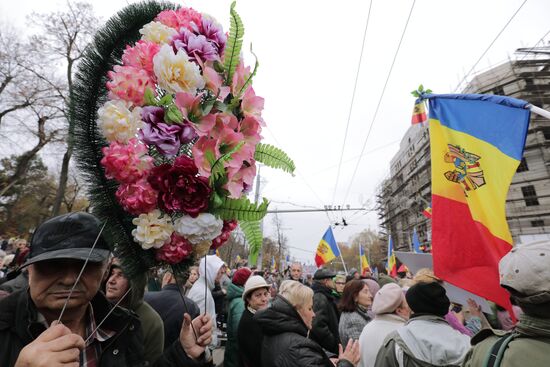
xmin=139 ymin=122 xmax=182 ymax=157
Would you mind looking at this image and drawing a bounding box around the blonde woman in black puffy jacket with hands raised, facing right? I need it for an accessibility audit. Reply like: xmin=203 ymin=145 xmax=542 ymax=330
xmin=254 ymin=280 xmax=359 ymax=367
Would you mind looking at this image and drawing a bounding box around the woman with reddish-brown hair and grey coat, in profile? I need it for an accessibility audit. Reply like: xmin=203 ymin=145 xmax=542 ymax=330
xmin=338 ymin=279 xmax=372 ymax=345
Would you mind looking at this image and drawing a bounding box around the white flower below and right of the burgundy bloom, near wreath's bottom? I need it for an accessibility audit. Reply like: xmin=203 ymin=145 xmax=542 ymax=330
xmin=174 ymin=213 xmax=223 ymax=245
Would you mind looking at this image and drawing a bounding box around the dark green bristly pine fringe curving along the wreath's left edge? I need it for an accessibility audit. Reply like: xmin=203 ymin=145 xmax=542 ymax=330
xmin=70 ymin=2 xmax=178 ymax=277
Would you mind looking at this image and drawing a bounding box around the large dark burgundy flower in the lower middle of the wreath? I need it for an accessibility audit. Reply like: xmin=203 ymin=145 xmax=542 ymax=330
xmin=148 ymin=155 xmax=212 ymax=218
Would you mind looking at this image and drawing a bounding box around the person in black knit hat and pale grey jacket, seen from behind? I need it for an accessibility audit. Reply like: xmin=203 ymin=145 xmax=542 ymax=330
xmin=375 ymin=282 xmax=470 ymax=367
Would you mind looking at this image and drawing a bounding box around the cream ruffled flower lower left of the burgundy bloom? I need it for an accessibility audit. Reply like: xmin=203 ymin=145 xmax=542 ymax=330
xmin=132 ymin=209 xmax=174 ymax=250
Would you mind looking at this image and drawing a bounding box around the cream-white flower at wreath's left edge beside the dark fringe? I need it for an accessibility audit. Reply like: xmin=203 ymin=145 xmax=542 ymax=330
xmin=97 ymin=100 xmax=143 ymax=144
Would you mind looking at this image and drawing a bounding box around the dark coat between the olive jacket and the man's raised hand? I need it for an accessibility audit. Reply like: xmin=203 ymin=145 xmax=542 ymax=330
xmin=144 ymin=284 xmax=200 ymax=349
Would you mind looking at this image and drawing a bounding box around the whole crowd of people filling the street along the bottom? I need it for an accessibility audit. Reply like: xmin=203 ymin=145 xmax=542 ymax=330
xmin=0 ymin=213 xmax=550 ymax=367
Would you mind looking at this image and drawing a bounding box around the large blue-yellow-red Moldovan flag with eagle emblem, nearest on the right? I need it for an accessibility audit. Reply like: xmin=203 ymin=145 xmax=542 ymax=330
xmin=427 ymin=94 xmax=530 ymax=309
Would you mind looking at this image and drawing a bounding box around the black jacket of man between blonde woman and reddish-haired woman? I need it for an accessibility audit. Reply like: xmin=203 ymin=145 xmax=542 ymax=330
xmin=311 ymin=282 xmax=340 ymax=354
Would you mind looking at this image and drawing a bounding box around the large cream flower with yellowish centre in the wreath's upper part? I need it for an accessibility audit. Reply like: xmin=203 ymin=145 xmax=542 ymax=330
xmin=153 ymin=45 xmax=204 ymax=94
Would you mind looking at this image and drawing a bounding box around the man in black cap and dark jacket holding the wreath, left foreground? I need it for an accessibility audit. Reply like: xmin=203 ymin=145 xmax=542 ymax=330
xmin=0 ymin=213 xmax=212 ymax=367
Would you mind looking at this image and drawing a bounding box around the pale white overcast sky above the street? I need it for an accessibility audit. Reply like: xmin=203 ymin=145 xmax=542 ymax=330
xmin=0 ymin=0 xmax=550 ymax=266
